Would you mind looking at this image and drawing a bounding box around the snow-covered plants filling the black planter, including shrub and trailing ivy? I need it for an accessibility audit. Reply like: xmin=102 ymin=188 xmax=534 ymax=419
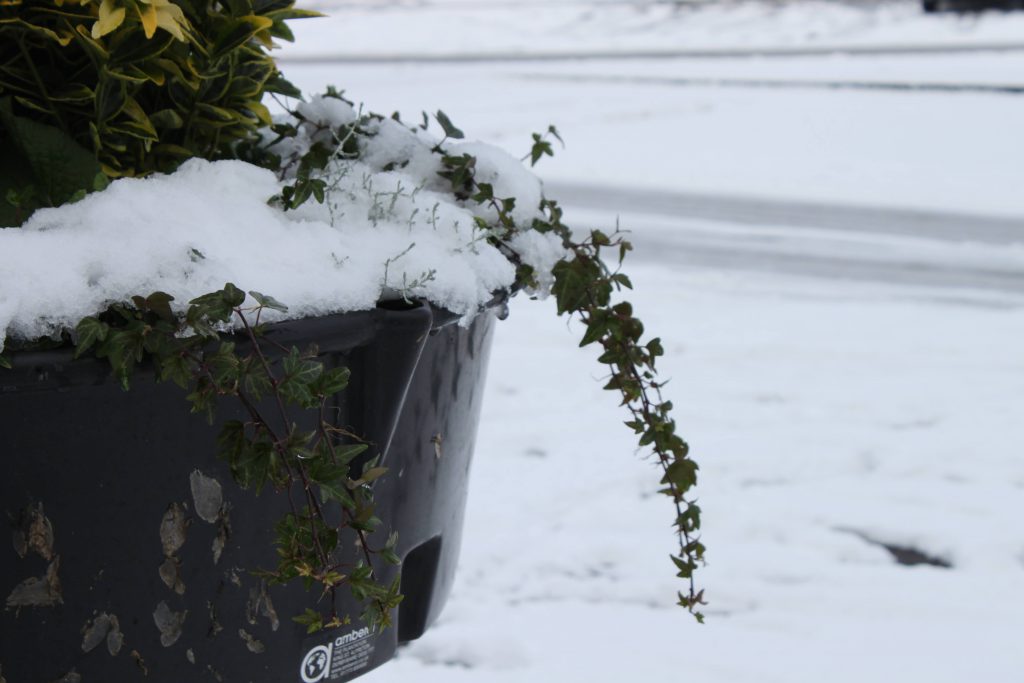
xmin=0 ymin=0 xmax=703 ymax=631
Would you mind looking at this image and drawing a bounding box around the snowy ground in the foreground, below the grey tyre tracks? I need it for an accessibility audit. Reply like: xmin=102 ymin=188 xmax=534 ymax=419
xmin=366 ymin=266 xmax=1024 ymax=683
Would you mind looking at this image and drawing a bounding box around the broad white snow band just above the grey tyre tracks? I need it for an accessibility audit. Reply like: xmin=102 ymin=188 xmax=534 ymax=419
xmin=287 ymin=55 xmax=1024 ymax=219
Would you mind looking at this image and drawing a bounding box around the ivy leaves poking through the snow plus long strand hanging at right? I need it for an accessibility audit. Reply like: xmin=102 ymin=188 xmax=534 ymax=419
xmin=274 ymin=100 xmax=705 ymax=621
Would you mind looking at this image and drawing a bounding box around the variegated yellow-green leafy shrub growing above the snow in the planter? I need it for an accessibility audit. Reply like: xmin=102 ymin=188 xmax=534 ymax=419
xmin=0 ymin=0 xmax=316 ymax=225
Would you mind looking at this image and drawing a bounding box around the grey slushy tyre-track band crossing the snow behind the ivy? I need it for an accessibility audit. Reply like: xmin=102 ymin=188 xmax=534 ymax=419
xmin=548 ymin=183 xmax=1024 ymax=305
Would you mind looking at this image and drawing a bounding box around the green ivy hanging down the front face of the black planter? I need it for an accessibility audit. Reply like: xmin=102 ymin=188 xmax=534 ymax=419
xmin=76 ymin=283 xmax=401 ymax=631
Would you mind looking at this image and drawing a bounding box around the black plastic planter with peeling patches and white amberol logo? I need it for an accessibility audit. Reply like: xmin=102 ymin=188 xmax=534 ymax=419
xmin=0 ymin=306 xmax=494 ymax=683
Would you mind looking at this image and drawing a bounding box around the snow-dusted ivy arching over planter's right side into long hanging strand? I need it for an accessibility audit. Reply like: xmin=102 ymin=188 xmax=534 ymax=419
xmin=247 ymin=91 xmax=705 ymax=621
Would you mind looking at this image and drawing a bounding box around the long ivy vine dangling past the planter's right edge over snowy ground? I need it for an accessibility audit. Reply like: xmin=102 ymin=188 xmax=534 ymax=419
xmin=441 ymin=136 xmax=706 ymax=623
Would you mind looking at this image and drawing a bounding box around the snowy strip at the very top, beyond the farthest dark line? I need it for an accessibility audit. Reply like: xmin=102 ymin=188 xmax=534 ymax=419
xmin=286 ymin=0 xmax=1024 ymax=58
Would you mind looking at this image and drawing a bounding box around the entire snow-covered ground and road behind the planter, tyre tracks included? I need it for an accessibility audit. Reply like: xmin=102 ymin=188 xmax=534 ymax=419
xmin=287 ymin=2 xmax=1024 ymax=683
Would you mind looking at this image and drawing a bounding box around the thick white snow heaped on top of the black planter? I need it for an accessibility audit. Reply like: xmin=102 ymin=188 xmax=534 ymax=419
xmin=0 ymin=97 xmax=564 ymax=352
